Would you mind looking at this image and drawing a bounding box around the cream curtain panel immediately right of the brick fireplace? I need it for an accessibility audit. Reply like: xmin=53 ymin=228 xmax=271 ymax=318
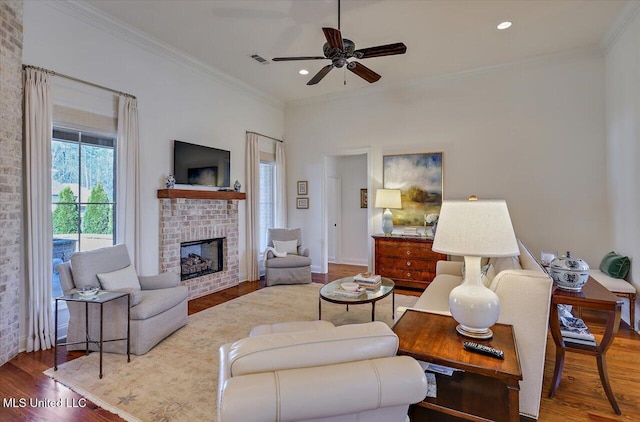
xmin=246 ymin=133 xmax=260 ymax=281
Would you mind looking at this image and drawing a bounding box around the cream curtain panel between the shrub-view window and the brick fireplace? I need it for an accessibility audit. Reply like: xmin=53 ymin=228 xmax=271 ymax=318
xmin=116 ymin=95 xmax=141 ymax=266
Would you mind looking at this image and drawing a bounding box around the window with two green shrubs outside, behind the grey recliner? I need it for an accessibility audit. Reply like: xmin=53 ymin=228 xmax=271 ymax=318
xmin=51 ymin=127 xmax=116 ymax=297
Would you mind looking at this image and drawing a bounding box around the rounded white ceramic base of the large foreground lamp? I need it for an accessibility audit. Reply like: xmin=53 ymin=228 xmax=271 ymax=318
xmin=449 ymin=256 xmax=500 ymax=339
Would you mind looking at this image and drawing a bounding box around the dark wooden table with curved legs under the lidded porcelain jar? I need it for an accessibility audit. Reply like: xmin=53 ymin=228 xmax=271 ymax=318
xmin=549 ymin=277 xmax=622 ymax=415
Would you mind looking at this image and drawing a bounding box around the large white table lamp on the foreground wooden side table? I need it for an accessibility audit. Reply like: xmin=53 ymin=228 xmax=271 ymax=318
xmin=432 ymin=197 xmax=520 ymax=339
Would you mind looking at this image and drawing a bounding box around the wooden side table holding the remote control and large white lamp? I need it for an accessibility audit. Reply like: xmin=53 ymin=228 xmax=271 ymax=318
xmin=393 ymin=310 xmax=522 ymax=421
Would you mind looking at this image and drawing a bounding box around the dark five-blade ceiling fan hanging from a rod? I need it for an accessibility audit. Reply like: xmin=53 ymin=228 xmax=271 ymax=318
xmin=273 ymin=0 xmax=407 ymax=85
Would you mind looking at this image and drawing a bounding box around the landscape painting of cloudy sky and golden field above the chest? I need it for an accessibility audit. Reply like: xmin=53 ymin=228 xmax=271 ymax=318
xmin=382 ymin=152 xmax=443 ymax=226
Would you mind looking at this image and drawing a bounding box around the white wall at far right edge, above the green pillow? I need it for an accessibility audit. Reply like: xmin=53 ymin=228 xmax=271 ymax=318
xmin=606 ymin=5 xmax=640 ymax=330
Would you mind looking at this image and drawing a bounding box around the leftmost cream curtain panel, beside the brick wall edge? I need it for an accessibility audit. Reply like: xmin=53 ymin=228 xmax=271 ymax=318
xmin=24 ymin=68 xmax=55 ymax=352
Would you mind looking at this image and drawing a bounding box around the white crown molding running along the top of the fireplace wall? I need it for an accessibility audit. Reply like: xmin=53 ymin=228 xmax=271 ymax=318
xmin=53 ymin=0 xmax=285 ymax=110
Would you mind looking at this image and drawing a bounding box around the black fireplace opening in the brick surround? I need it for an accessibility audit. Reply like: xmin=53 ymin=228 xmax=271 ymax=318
xmin=180 ymin=237 xmax=224 ymax=280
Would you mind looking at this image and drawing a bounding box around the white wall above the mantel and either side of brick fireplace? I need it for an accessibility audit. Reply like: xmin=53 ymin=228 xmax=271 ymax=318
xmin=23 ymin=1 xmax=284 ymax=342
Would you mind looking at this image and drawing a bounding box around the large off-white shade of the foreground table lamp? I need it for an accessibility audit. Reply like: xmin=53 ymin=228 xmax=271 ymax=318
xmin=433 ymin=200 xmax=520 ymax=257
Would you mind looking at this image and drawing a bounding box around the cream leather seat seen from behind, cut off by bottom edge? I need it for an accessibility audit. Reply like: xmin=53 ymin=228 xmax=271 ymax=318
xmin=218 ymin=321 xmax=427 ymax=422
